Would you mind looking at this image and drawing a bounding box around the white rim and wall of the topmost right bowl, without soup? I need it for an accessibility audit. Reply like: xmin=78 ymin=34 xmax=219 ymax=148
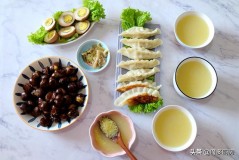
xmin=174 ymin=11 xmax=215 ymax=48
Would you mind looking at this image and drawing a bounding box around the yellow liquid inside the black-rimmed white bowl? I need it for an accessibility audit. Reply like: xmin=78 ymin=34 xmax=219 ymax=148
xmin=176 ymin=61 xmax=212 ymax=98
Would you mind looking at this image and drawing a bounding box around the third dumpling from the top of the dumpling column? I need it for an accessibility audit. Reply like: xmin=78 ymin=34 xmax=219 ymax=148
xmin=118 ymin=47 xmax=161 ymax=59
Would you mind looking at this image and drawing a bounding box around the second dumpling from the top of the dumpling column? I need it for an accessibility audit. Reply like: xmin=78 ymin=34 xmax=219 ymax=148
xmin=120 ymin=38 xmax=163 ymax=49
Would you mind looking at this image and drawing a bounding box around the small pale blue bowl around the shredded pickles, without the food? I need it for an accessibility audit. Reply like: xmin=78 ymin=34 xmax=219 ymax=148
xmin=77 ymin=39 xmax=110 ymax=72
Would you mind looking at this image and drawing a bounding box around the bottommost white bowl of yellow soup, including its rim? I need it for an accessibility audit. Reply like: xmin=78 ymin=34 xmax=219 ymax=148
xmin=152 ymin=105 xmax=197 ymax=152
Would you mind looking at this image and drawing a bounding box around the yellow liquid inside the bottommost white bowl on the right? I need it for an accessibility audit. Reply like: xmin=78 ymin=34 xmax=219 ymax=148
xmin=154 ymin=108 xmax=192 ymax=147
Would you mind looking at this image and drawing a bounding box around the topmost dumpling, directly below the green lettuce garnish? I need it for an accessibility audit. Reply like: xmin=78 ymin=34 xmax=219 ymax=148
xmin=120 ymin=27 xmax=160 ymax=38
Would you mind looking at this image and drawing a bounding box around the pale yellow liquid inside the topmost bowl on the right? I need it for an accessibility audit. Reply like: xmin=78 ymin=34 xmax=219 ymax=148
xmin=176 ymin=14 xmax=209 ymax=47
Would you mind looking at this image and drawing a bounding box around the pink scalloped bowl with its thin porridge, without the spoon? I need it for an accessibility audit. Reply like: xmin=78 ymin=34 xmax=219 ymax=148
xmin=89 ymin=110 xmax=136 ymax=157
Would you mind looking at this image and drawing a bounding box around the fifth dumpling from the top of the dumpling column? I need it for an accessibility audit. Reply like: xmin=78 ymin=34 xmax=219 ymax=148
xmin=117 ymin=67 xmax=159 ymax=82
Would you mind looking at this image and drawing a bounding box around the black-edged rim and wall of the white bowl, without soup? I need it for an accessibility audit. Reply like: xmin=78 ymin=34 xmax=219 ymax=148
xmin=173 ymin=57 xmax=218 ymax=100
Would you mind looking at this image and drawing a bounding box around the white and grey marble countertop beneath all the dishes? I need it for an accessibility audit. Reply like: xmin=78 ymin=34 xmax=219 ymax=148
xmin=0 ymin=0 xmax=239 ymax=160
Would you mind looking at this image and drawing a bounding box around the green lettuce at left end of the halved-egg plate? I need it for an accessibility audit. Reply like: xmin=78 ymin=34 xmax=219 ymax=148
xmin=27 ymin=26 xmax=47 ymax=44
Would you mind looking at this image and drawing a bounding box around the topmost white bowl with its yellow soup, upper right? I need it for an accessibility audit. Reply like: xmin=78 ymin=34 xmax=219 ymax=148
xmin=174 ymin=11 xmax=214 ymax=48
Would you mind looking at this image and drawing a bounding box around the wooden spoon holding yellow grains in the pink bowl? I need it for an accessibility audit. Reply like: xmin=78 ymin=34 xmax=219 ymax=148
xmin=100 ymin=117 xmax=137 ymax=160
